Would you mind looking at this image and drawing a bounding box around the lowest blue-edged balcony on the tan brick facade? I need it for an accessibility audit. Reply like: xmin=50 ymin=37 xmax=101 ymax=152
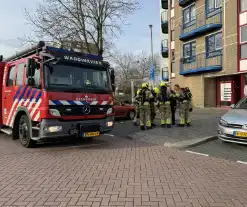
xmin=180 ymin=51 xmax=222 ymax=76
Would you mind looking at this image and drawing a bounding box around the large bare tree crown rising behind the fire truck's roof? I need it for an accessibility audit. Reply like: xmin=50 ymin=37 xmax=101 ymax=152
xmin=21 ymin=0 xmax=139 ymax=55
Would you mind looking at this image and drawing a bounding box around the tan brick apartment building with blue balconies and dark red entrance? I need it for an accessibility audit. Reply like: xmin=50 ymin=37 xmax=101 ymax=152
xmin=161 ymin=0 xmax=247 ymax=107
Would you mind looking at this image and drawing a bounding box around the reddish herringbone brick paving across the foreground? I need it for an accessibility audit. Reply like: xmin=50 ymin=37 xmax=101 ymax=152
xmin=0 ymin=137 xmax=247 ymax=207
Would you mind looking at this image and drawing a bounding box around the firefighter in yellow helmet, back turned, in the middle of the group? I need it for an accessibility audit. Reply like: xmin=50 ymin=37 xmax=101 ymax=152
xmin=158 ymin=82 xmax=171 ymax=128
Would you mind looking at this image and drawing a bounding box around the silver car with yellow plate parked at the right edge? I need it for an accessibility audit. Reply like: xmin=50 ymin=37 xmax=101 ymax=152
xmin=218 ymin=97 xmax=247 ymax=144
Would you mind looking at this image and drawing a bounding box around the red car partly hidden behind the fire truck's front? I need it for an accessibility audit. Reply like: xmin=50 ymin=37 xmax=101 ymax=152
xmin=113 ymin=101 xmax=136 ymax=120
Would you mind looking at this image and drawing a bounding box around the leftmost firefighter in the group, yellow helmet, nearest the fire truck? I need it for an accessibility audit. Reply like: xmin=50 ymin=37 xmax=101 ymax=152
xmin=136 ymin=83 xmax=153 ymax=130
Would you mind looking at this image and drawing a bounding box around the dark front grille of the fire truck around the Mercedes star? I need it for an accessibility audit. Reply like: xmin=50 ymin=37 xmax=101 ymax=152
xmin=50 ymin=106 xmax=109 ymax=116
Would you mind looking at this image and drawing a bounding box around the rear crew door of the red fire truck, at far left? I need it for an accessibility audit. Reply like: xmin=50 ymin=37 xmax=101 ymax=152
xmin=3 ymin=65 xmax=17 ymax=126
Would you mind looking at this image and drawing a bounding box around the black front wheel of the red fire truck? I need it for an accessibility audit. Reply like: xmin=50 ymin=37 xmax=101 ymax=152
xmin=18 ymin=115 xmax=34 ymax=148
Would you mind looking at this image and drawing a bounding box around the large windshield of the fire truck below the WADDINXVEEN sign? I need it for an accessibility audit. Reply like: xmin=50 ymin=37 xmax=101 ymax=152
xmin=44 ymin=62 xmax=111 ymax=93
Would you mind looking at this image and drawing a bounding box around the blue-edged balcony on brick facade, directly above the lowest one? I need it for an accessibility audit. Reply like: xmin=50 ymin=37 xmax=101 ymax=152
xmin=179 ymin=9 xmax=222 ymax=41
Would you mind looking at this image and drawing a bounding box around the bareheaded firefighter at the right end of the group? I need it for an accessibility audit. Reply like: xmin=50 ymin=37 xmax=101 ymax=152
xmin=174 ymin=84 xmax=192 ymax=127
